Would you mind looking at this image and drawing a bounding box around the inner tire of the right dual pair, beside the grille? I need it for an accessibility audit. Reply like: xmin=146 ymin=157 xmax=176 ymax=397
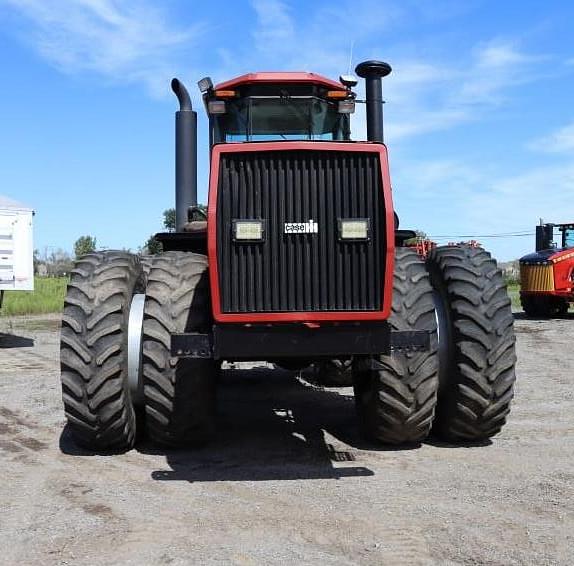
xmin=353 ymin=248 xmax=438 ymax=444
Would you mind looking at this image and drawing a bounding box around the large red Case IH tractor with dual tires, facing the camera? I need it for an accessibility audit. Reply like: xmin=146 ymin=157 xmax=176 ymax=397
xmin=61 ymin=61 xmax=515 ymax=451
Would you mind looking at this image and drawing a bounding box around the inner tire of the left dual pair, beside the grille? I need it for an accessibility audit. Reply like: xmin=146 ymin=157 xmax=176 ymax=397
xmin=143 ymin=252 xmax=217 ymax=447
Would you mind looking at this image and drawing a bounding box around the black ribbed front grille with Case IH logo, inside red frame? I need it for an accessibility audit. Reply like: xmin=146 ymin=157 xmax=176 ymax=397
xmin=217 ymin=149 xmax=386 ymax=313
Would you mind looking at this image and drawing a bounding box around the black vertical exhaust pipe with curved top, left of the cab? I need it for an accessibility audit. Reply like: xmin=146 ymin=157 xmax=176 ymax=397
xmin=171 ymin=79 xmax=197 ymax=232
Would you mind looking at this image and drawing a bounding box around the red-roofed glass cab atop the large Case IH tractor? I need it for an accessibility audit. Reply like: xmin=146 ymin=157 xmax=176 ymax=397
xmin=198 ymin=72 xmax=356 ymax=145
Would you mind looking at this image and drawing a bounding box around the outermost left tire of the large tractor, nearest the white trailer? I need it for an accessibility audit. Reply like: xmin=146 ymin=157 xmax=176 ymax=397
xmin=60 ymin=251 xmax=145 ymax=451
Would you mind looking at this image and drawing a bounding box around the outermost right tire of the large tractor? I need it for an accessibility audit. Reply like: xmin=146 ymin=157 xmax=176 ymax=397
xmin=427 ymin=246 xmax=516 ymax=442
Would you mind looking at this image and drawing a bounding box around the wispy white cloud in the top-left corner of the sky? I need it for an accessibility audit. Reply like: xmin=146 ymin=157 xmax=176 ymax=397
xmin=3 ymin=0 xmax=207 ymax=94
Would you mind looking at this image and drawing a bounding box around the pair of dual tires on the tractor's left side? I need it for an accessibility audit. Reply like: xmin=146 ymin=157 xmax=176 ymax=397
xmin=60 ymin=251 xmax=215 ymax=451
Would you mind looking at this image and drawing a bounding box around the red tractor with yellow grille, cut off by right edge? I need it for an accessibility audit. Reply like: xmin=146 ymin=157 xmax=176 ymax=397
xmin=520 ymin=223 xmax=574 ymax=317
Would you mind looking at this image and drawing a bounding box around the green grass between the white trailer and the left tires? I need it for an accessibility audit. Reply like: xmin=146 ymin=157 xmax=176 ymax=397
xmin=0 ymin=277 xmax=68 ymax=316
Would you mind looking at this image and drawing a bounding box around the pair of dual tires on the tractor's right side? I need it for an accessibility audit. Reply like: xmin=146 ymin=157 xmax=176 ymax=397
xmin=354 ymin=246 xmax=516 ymax=444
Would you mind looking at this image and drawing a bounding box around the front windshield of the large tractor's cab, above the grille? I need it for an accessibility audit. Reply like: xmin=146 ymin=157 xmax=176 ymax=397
xmin=214 ymin=96 xmax=349 ymax=142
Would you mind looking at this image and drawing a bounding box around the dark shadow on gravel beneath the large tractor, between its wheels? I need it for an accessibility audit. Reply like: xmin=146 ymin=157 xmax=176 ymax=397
xmin=144 ymin=368 xmax=379 ymax=482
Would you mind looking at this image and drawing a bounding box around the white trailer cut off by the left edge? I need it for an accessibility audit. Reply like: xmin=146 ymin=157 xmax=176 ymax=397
xmin=0 ymin=196 xmax=34 ymax=305
